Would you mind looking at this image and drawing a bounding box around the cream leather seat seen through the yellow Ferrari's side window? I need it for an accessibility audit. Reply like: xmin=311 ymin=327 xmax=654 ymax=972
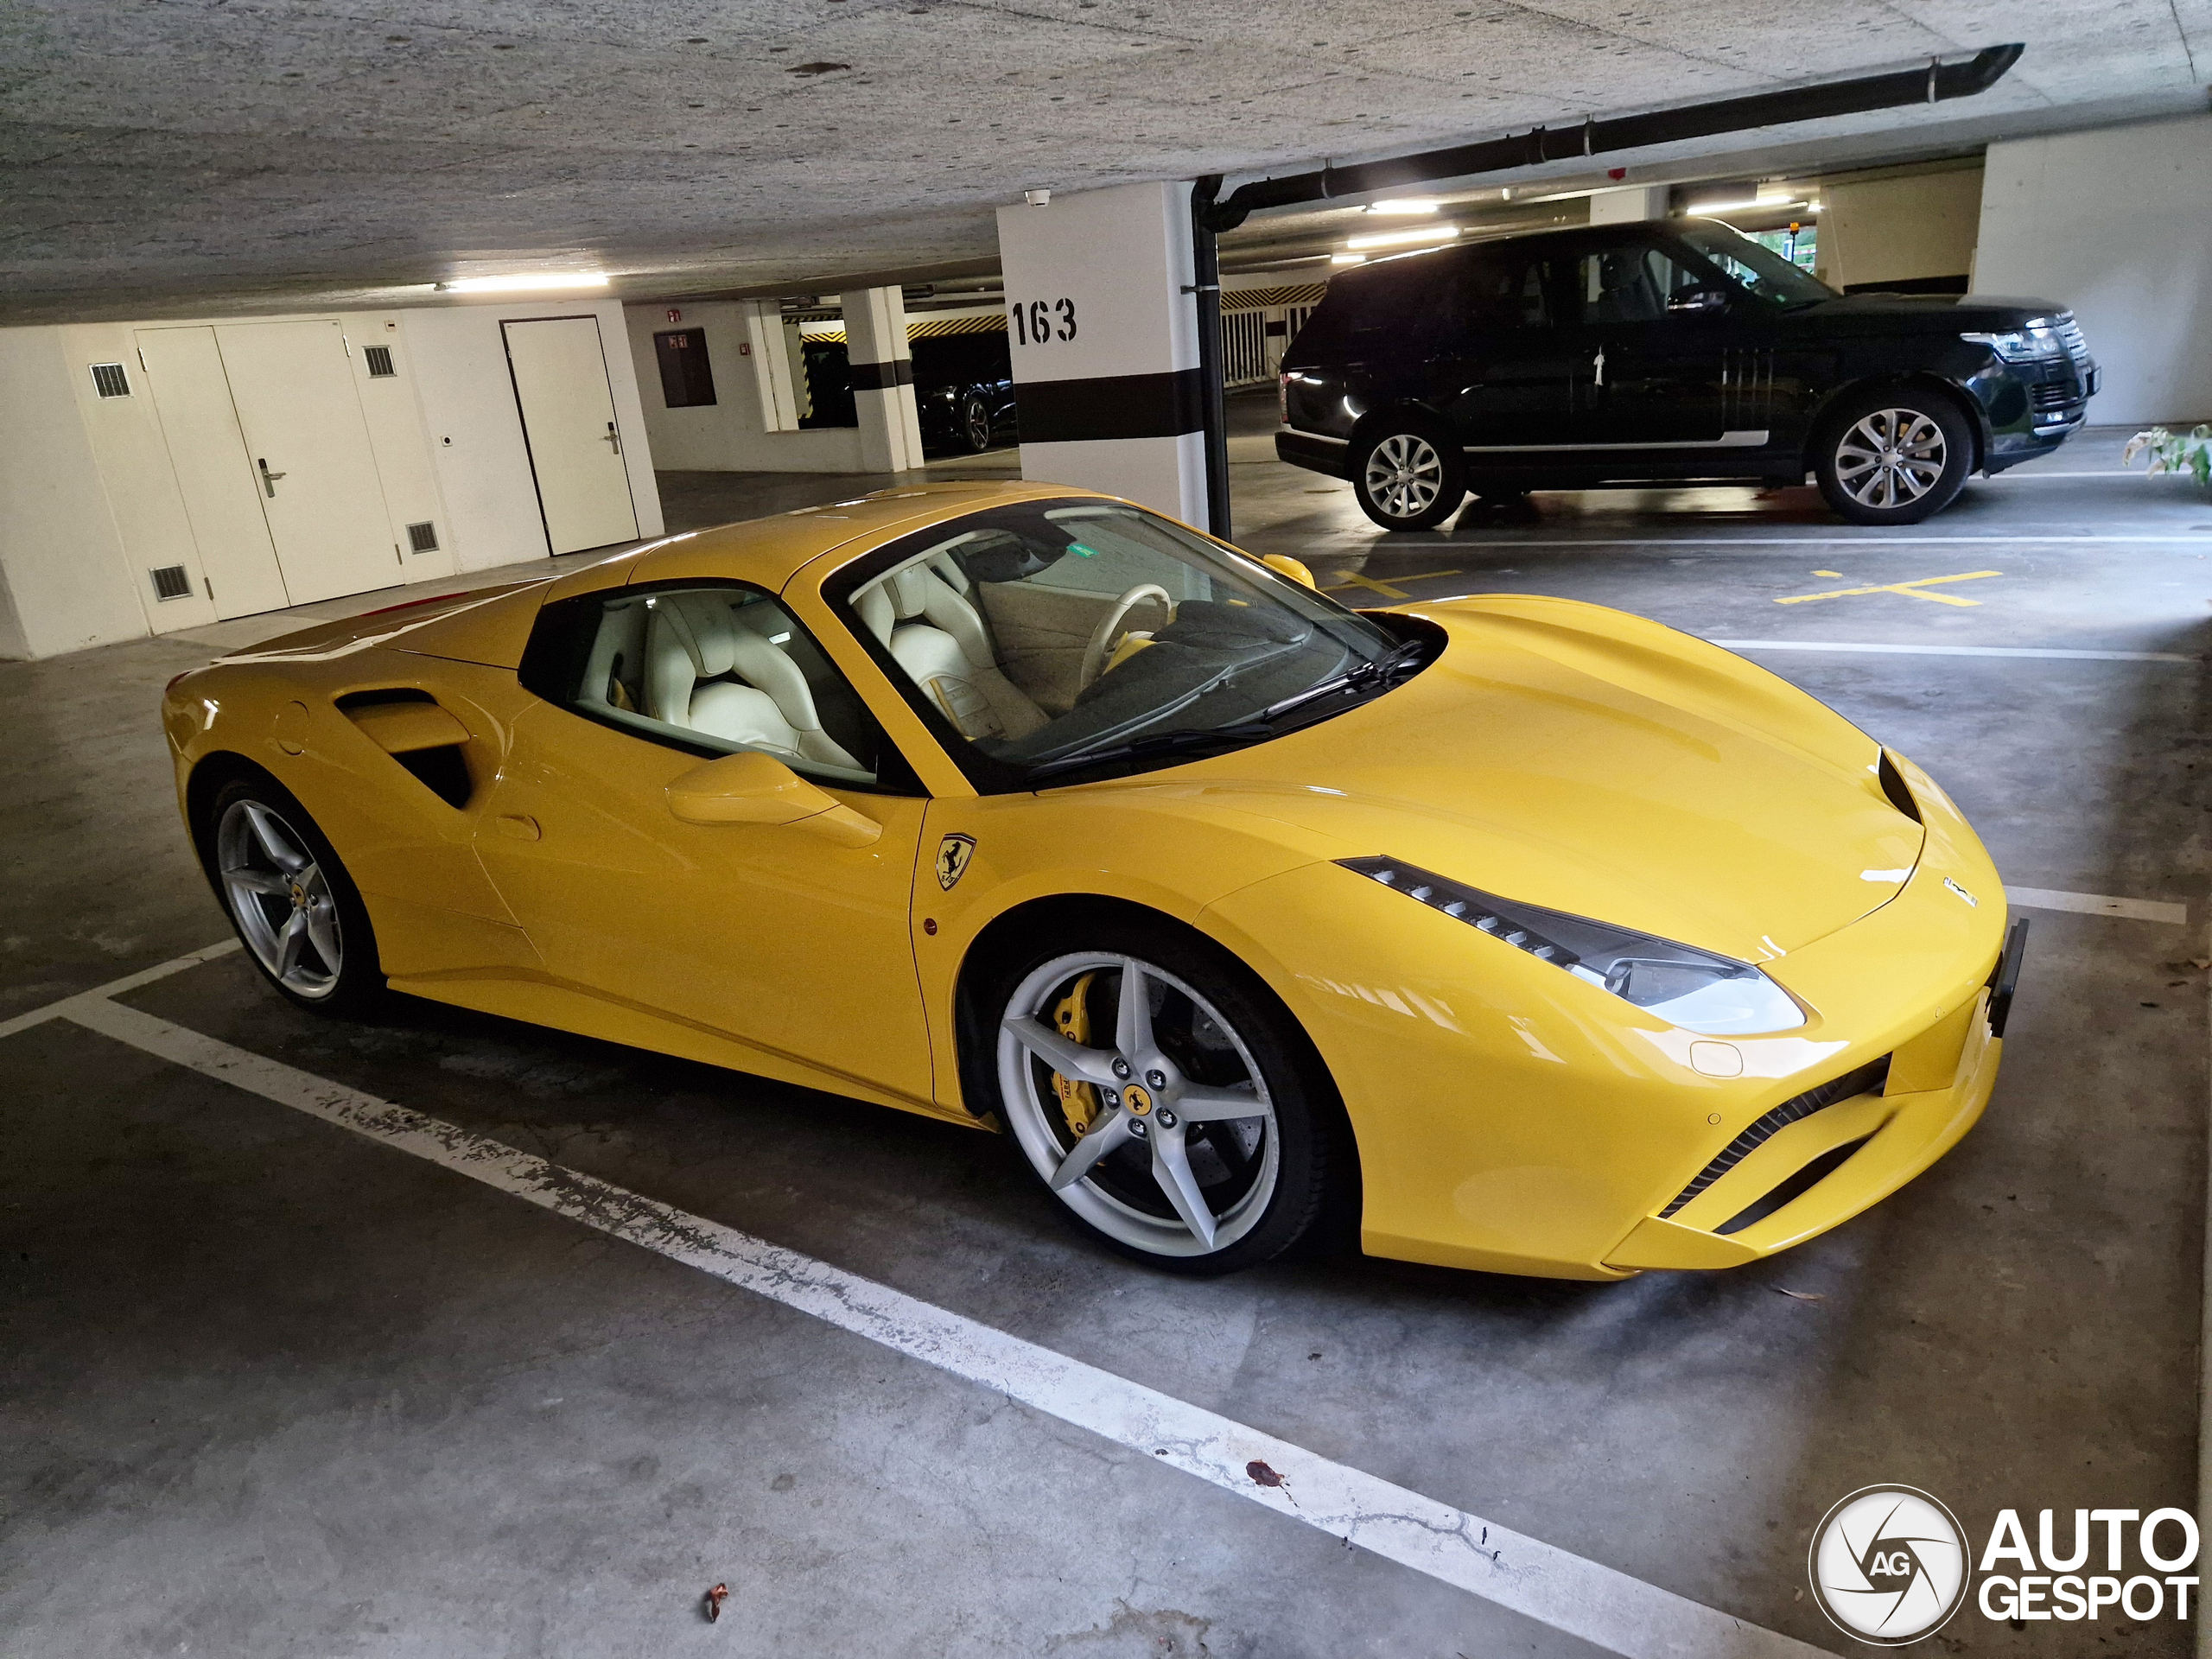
xmin=646 ymin=593 xmax=862 ymax=772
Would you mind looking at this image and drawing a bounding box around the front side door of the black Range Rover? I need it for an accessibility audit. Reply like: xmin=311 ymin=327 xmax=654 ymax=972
xmin=1575 ymin=234 xmax=1763 ymax=449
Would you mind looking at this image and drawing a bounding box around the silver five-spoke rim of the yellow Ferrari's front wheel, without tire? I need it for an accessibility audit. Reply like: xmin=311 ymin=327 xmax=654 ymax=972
xmin=998 ymin=951 xmax=1281 ymax=1256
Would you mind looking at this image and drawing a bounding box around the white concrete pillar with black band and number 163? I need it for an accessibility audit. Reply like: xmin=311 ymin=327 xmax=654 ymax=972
xmin=998 ymin=183 xmax=1205 ymax=524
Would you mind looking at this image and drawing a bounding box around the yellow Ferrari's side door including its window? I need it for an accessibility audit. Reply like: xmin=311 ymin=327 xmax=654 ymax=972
xmin=475 ymin=582 xmax=931 ymax=1103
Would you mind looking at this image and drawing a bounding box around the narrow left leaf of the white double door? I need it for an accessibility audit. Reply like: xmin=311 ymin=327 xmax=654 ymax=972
xmin=137 ymin=327 xmax=292 ymax=617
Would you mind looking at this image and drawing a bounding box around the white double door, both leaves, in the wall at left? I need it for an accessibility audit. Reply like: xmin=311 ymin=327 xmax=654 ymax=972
xmin=137 ymin=323 xmax=404 ymax=617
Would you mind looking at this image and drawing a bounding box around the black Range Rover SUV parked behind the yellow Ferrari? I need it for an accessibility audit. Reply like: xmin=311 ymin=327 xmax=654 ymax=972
xmin=1274 ymin=219 xmax=2097 ymax=531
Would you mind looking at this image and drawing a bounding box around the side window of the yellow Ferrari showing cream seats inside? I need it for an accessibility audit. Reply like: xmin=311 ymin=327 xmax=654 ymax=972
xmin=522 ymin=584 xmax=902 ymax=785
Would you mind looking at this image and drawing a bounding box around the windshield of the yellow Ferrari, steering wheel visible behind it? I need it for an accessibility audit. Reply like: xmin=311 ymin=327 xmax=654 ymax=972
xmin=830 ymin=500 xmax=1405 ymax=790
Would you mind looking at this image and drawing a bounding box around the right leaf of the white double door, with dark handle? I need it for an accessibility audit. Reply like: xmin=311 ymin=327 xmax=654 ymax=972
xmin=214 ymin=323 xmax=404 ymax=604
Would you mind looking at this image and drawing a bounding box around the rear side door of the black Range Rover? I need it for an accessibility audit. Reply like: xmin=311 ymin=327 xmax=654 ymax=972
xmin=1438 ymin=244 xmax=1577 ymax=448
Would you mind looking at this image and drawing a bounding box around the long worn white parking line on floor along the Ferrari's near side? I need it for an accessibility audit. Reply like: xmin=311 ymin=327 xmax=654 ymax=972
xmin=30 ymin=986 xmax=1822 ymax=1659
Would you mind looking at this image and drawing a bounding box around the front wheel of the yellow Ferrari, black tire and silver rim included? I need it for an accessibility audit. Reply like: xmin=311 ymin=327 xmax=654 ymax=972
xmin=976 ymin=925 xmax=1350 ymax=1274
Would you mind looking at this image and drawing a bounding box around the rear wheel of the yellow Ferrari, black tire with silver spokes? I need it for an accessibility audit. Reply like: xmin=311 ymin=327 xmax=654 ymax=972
xmin=193 ymin=774 xmax=385 ymax=1015
